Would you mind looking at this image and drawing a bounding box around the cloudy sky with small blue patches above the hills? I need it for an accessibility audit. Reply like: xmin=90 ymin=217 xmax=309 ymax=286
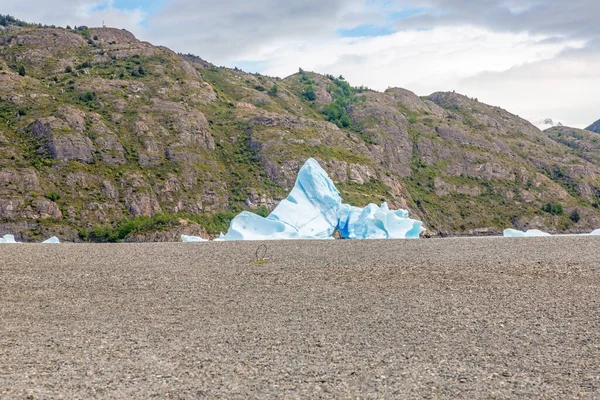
xmin=0 ymin=0 xmax=600 ymax=128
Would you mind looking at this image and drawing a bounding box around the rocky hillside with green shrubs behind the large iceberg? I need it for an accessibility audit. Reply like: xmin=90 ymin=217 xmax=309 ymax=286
xmin=0 ymin=21 xmax=600 ymax=241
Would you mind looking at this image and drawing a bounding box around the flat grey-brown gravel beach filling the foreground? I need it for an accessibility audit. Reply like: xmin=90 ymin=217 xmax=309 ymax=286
xmin=0 ymin=237 xmax=600 ymax=399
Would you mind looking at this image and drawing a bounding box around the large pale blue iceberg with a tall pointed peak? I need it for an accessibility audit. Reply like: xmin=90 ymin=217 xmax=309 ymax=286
xmin=216 ymin=158 xmax=424 ymax=240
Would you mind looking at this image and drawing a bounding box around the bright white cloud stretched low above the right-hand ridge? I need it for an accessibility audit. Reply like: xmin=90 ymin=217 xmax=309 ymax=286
xmin=255 ymin=27 xmax=583 ymax=89
